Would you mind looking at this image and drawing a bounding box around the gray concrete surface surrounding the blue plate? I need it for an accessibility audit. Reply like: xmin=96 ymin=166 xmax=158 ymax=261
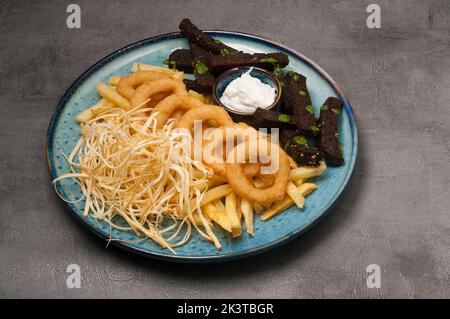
xmin=0 ymin=0 xmax=450 ymax=298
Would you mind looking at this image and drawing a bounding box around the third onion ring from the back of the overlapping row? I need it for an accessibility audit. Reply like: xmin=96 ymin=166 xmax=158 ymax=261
xmin=154 ymin=94 xmax=203 ymax=128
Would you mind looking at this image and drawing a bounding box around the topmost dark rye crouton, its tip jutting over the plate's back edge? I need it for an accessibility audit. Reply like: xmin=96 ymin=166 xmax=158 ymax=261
xmin=179 ymin=19 xmax=238 ymax=54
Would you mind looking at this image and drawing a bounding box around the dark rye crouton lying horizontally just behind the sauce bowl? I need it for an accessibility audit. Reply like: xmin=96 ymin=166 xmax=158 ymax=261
xmin=208 ymin=52 xmax=289 ymax=74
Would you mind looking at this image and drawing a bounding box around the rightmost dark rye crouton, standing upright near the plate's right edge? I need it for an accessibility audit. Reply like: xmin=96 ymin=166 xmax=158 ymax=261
xmin=319 ymin=97 xmax=344 ymax=166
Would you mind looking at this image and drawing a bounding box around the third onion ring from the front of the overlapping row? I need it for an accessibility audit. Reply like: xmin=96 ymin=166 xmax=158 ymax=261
xmin=178 ymin=104 xmax=234 ymax=133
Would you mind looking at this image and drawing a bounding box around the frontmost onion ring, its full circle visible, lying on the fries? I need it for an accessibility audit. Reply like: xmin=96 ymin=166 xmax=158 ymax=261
xmin=226 ymin=140 xmax=290 ymax=203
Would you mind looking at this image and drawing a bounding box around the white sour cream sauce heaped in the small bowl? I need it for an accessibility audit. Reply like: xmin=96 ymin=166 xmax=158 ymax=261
xmin=220 ymin=69 xmax=277 ymax=113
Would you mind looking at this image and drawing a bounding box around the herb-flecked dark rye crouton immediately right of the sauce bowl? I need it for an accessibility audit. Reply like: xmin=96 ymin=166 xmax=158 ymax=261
xmin=283 ymin=72 xmax=319 ymax=136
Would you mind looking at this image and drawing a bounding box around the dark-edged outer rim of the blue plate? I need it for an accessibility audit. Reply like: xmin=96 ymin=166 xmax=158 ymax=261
xmin=45 ymin=30 xmax=358 ymax=263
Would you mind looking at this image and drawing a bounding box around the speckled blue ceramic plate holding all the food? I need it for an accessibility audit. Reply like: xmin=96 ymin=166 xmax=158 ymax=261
xmin=47 ymin=31 xmax=358 ymax=262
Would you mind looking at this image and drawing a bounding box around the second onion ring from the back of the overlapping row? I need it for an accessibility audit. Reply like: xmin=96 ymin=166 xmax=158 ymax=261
xmin=130 ymin=79 xmax=187 ymax=108
